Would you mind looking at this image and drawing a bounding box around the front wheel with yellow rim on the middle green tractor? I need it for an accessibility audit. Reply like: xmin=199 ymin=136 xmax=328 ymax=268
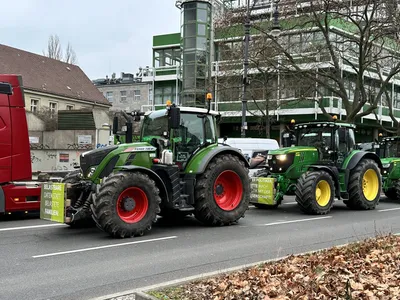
xmin=296 ymin=171 xmax=335 ymax=215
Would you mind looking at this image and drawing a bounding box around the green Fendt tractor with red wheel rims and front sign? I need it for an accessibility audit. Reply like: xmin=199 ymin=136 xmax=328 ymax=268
xmin=41 ymin=94 xmax=250 ymax=238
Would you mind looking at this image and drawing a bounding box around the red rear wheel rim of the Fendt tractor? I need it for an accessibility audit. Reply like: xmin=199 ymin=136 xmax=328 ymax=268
xmin=214 ymin=171 xmax=243 ymax=211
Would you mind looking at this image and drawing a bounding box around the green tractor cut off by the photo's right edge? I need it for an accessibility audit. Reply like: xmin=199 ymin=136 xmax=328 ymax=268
xmin=376 ymin=136 xmax=400 ymax=200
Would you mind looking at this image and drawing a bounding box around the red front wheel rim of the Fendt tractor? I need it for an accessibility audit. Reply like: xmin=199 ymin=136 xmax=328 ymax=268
xmin=117 ymin=187 xmax=149 ymax=223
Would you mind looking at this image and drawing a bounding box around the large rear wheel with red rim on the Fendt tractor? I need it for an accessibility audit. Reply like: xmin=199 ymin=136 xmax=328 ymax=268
xmin=194 ymin=154 xmax=250 ymax=226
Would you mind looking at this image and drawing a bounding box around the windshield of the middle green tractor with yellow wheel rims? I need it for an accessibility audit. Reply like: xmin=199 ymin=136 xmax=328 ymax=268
xmin=297 ymin=127 xmax=332 ymax=148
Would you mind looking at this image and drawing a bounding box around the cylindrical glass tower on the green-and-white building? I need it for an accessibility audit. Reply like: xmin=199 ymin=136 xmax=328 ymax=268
xmin=181 ymin=1 xmax=211 ymax=107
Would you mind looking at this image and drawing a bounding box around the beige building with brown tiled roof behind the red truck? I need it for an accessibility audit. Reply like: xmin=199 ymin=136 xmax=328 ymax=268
xmin=0 ymin=45 xmax=111 ymax=171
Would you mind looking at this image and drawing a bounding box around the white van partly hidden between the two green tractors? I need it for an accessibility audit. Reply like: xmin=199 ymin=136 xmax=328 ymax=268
xmin=218 ymin=138 xmax=279 ymax=159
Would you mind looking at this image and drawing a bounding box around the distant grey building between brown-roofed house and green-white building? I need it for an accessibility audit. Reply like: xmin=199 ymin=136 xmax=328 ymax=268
xmin=93 ymin=69 xmax=153 ymax=111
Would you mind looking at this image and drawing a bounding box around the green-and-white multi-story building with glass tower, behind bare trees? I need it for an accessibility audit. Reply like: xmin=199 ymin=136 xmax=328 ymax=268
xmin=139 ymin=0 xmax=400 ymax=141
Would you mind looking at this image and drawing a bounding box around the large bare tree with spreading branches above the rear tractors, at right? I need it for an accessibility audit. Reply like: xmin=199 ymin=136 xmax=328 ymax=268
xmin=253 ymin=0 xmax=400 ymax=123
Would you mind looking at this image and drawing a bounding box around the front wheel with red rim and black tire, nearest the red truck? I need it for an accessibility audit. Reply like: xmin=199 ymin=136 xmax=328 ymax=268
xmin=93 ymin=172 xmax=161 ymax=238
